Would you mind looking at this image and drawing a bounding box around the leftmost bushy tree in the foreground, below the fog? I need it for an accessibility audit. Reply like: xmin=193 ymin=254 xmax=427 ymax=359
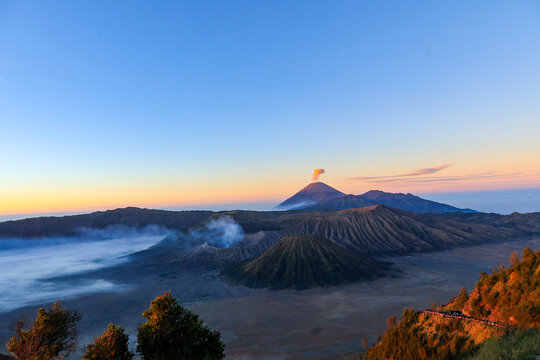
xmin=6 ymin=301 xmax=81 ymax=360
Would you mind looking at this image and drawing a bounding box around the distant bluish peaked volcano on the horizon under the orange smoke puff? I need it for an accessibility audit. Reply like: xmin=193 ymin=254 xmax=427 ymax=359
xmin=276 ymin=182 xmax=476 ymax=214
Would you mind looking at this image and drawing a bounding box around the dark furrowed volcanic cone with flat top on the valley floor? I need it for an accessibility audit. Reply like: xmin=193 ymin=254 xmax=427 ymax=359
xmin=225 ymin=235 xmax=385 ymax=289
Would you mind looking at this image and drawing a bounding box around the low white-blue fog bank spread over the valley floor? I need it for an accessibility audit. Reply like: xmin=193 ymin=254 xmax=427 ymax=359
xmin=0 ymin=231 xmax=165 ymax=312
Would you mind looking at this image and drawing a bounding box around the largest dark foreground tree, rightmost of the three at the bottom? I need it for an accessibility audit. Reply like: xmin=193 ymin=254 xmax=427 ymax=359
xmin=137 ymin=291 xmax=225 ymax=360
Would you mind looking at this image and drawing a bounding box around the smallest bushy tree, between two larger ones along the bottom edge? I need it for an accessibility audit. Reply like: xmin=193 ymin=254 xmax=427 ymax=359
xmin=82 ymin=324 xmax=134 ymax=360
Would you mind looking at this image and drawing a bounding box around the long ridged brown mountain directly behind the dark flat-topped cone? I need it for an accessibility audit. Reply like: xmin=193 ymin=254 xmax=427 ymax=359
xmin=289 ymin=205 xmax=522 ymax=254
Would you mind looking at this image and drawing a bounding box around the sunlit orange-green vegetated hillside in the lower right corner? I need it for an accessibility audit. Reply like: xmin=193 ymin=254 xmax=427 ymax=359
xmin=362 ymin=249 xmax=540 ymax=360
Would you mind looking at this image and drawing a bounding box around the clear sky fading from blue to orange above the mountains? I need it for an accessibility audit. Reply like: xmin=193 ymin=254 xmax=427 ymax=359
xmin=0 ymin=0 xmax=540 ymax=215
